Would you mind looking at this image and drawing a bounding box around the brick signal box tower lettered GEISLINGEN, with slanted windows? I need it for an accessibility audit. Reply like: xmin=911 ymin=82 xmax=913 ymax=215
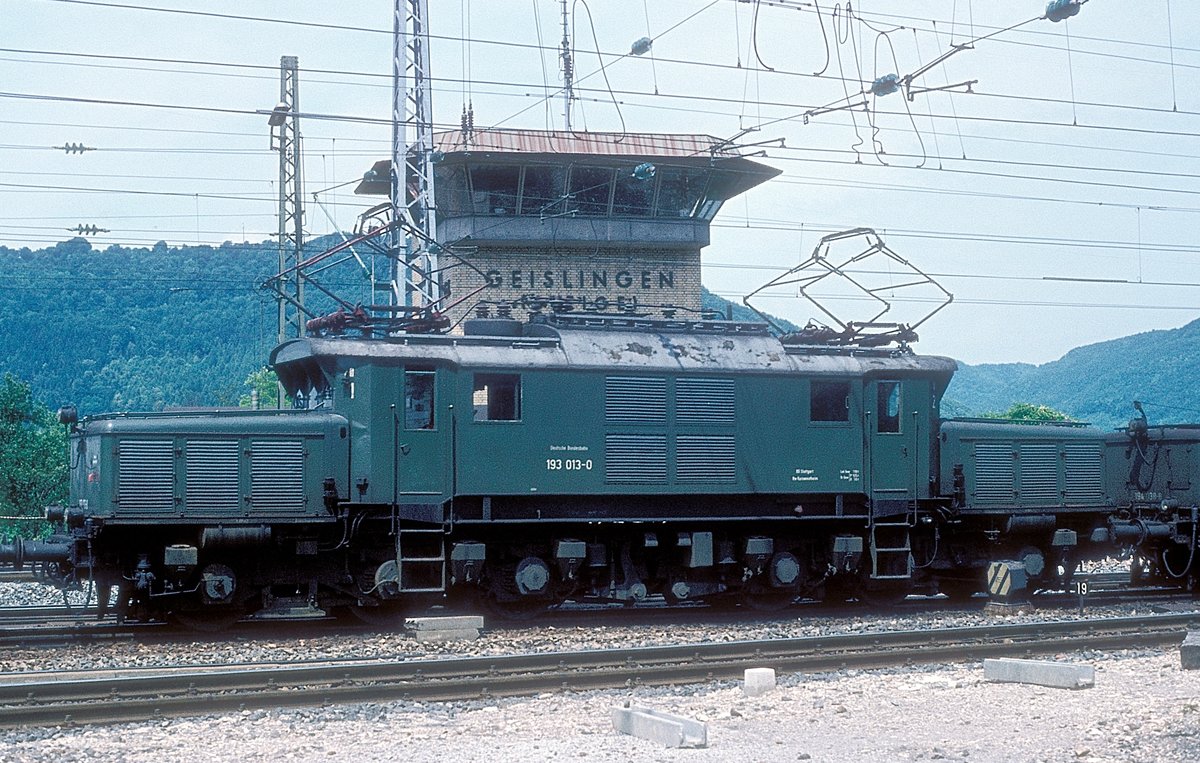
xmin=355 ymin=130 xmax=779 ymax=324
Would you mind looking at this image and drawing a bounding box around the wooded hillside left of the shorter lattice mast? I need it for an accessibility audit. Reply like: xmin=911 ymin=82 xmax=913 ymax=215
xmin=0 ymin=239 xmax=277 ymax=414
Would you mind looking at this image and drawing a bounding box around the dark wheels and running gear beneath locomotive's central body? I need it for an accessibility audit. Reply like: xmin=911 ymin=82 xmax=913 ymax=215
xmin=441 ymin=523 xmax=911 ymax=614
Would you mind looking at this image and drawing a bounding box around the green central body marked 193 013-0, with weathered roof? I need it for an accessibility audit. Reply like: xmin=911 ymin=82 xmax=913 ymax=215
xmin=272 ymin=322 xmax=955 ymax=519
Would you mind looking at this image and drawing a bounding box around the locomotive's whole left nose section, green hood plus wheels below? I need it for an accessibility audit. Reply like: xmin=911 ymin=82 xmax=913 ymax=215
xmin=18 ymin=411 xmax=349 ymax=612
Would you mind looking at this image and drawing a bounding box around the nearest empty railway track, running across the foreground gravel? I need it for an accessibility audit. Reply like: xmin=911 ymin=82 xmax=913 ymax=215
xmin=0 ymin=613 xmax=1200 ymax=728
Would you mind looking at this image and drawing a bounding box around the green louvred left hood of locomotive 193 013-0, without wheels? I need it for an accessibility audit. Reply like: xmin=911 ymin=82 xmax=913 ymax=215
xmin=70 ymin=410 xmax=349 ymax=525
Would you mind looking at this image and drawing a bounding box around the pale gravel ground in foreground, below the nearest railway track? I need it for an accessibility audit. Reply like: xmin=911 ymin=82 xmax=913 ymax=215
xmin=0 ymin=651 xmax=1200 ymax=763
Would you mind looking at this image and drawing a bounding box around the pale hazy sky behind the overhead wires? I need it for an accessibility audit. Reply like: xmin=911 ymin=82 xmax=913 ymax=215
xmin=0 ymin=0 xmax=1200 ymax=362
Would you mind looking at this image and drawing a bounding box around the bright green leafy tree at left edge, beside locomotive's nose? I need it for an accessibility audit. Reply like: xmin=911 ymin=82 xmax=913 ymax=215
xmin=0 ymin=373 xmax=67 ymax=536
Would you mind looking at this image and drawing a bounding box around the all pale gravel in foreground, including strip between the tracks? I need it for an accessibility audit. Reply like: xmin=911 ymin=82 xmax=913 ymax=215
xmin=0 ymin=584 xmax=1200 ymax=763
